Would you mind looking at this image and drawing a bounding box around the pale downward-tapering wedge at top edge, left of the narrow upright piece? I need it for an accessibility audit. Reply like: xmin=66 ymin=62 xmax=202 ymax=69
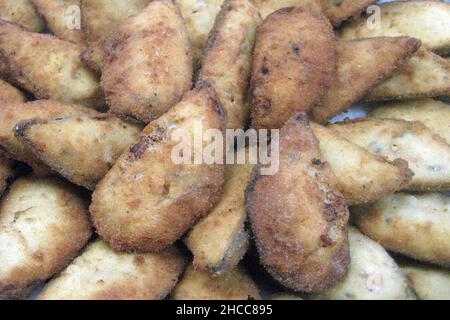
xmin=175 ymin=0 xmax=224 ymax=68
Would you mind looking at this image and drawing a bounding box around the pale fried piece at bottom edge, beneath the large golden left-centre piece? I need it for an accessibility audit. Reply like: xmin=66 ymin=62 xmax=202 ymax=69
xmin=37 ymin=240 xmax=186 ymax=300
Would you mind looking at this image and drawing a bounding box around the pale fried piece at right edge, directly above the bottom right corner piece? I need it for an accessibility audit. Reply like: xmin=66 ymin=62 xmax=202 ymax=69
xmin=352 ymin=193 xmax=450 ymax=267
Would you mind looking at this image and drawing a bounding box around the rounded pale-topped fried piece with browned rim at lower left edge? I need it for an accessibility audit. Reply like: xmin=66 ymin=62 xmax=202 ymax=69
xmin=0 ymin=177 xmax=92 ymax=299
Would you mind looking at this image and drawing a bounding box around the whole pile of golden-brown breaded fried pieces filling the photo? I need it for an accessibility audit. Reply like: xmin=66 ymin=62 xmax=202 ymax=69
xmin=0 ymin=0 xmax=450 ymax=300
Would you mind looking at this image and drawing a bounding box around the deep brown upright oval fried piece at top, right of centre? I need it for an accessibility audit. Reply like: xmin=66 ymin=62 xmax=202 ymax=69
xmin=251 ymin=8 xmax=335 ymax=129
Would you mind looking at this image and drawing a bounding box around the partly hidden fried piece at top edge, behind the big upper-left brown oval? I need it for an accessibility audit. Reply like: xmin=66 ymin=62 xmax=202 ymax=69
xmin=81 ymin=0 xmax=151 ymax=71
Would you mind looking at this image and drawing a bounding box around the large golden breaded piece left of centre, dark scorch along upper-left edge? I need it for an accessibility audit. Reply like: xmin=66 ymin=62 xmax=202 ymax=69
xmin=91 ymin=83 xmax=225 ymax=252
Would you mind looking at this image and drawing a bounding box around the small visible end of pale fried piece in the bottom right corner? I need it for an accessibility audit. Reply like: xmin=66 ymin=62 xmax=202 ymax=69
xmin=401 ymin=263 xmax=450 ymax=300
